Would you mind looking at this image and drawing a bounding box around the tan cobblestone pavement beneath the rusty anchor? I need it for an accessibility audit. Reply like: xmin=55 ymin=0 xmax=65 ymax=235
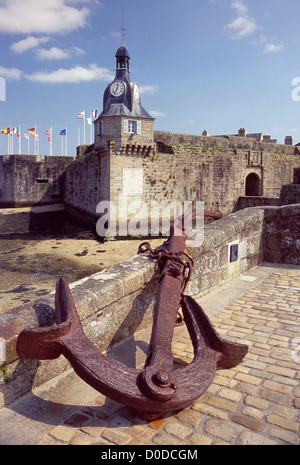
xmin=0 ymin=267 xmax=300 ymax=447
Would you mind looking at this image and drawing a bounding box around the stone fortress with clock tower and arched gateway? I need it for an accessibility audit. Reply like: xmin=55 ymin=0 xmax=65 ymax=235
xmin=64 ymin=44 xmax=300 ymax=234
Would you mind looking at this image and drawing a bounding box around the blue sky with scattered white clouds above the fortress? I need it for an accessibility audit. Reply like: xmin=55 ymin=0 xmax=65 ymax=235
xmin=0 ymin=0 xmax=300 ymax=155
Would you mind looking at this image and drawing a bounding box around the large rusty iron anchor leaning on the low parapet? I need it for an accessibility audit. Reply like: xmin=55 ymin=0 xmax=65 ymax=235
xmin=17 ymin=208 xmax=248 ymax=420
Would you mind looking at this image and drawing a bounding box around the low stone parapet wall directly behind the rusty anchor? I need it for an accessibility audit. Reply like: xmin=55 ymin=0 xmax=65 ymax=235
xmin=0 ymin=204 xmax=300 ymax=407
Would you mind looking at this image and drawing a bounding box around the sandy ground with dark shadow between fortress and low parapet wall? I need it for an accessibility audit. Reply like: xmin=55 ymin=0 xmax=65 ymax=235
xmin=0 ymin=206 xmax=164 ymax=313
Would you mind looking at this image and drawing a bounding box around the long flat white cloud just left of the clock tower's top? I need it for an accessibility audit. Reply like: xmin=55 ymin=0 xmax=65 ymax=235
xmin=25 ymin=64 xmax=114 ymax=84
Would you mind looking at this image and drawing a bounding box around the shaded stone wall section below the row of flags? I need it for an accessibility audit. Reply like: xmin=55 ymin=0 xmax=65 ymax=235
xmin=0 ymin=155 xmax=74 ymax=207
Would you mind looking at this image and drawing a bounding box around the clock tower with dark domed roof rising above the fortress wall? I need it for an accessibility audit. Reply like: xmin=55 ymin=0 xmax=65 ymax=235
xmin=94 ymin=43 xmax=154 ymax=153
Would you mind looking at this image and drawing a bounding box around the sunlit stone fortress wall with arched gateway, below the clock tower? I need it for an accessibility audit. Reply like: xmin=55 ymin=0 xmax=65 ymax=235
xmin=64 ymin=131 xmax=300 ymax=225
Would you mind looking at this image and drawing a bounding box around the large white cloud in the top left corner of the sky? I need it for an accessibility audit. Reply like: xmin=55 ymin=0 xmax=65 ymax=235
xmin=0 ymin=0 xmax=92 ymax=34
